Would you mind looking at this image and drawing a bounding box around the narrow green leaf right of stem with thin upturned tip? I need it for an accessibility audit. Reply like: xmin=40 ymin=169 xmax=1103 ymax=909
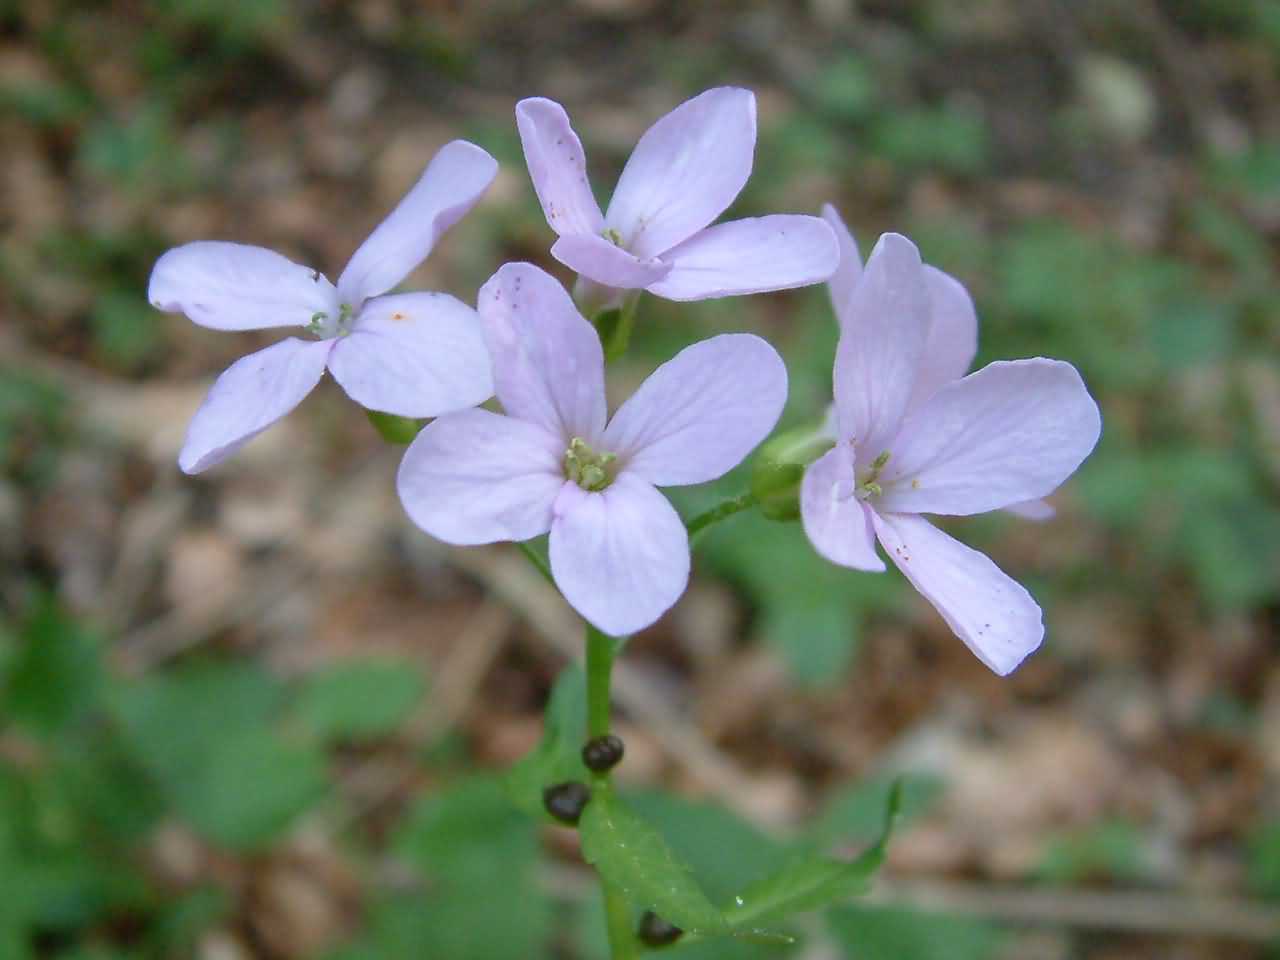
xmin=724 ymin=782 xmax=902 ymax=927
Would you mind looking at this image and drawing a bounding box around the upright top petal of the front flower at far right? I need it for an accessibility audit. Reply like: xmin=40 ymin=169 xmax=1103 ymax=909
xmin=835 ymin=233 xmax=929 ymax=465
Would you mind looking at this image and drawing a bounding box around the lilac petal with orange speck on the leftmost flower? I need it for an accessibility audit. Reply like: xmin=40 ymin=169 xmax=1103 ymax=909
xmin=329 ymin=293 xmax=493 ymax=417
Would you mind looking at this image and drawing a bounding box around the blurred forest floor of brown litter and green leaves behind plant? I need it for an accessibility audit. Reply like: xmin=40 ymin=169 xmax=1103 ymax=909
xmin=0 ymin=0 xmax=1280 ymax=960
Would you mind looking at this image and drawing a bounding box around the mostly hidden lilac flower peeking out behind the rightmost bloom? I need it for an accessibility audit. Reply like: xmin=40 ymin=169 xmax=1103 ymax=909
xmin=822 ymin=204 xmax=1053 ymax=521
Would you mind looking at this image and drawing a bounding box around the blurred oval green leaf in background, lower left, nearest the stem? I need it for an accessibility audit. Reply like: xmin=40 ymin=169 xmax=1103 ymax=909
xmin=294 ymin=659 xmax=424 ymax=740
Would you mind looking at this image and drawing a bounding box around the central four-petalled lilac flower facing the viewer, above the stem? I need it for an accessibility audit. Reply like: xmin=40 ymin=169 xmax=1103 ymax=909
xmin=398 ymin=264 xmax=787 ymax=636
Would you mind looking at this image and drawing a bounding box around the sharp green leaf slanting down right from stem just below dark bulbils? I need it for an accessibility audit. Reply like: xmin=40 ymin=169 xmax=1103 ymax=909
xmin=579 ymin=787 xmax=727 ymax=933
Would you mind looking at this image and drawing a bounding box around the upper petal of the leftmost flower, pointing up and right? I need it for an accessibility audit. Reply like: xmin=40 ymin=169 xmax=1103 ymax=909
xmin=338 ymin=140 xmax=498 ymax=306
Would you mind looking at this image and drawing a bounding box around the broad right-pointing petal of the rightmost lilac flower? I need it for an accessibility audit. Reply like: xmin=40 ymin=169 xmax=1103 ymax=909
xmin=877 ymin=358 xmax=1102 ymax=515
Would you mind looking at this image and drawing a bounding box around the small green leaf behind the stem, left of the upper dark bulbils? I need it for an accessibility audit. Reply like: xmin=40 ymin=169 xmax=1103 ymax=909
xmin=506 ymin=663 xmax=590 ymax=817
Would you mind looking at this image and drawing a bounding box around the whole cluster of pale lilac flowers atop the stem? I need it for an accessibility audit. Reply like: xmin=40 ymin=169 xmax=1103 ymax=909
xmin=150 ymin=87 xmax=1101 ymax=673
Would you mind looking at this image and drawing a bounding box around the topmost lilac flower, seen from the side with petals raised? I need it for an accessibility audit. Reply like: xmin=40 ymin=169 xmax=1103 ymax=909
xmin=516 ymin=87 xmax=838 ymax=300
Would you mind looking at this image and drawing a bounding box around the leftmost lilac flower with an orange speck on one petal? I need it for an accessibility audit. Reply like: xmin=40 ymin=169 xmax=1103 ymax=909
xmin=147 ymin=141 xmax=498 ymax=474
